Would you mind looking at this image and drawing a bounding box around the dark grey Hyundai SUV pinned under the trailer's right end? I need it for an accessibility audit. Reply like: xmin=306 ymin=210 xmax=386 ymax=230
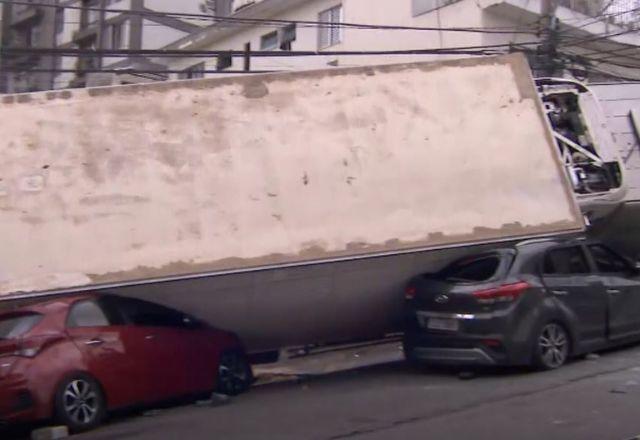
xmin=404 ymin=240 xmax=640 ymax=369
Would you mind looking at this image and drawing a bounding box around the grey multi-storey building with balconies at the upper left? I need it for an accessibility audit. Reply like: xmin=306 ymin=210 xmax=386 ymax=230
xmin=1 ymin=0 xmax=203 ymax=93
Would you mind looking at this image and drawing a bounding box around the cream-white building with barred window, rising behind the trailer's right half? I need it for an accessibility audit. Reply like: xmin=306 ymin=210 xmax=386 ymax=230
xmin=154 ymin=0 xmax=640 ymax=80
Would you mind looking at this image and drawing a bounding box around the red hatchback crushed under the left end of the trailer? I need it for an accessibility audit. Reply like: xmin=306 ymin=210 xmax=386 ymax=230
xmin=0 ymin=294 xmax=253 ymax=431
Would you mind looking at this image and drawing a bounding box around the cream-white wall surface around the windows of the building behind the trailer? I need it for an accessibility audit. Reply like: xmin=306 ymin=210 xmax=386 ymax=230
xmin=156 ymin=0 xmax=535 ymax=77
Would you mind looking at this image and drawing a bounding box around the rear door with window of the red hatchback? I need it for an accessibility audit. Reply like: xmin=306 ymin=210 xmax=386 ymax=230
xmin=67 ymin=299 xmax=150 ymax=408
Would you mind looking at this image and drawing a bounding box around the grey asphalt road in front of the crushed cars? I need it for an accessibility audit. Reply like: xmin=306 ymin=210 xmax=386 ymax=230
xmin=8 ymin=346 xmax=640 ymax=440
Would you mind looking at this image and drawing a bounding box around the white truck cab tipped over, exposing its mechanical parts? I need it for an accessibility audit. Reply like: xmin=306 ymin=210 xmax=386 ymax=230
xmin=536 ymin=78 xmax=626 ymax=221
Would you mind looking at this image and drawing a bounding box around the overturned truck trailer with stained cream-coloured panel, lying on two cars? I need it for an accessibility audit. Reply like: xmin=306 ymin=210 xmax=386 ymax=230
xmin=0 ymin=55 xmax=584 ymax=350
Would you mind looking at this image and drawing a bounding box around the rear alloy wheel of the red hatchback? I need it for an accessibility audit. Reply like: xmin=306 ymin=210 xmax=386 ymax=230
xmin=55 ymin=374 xmax=107 ymax=432
